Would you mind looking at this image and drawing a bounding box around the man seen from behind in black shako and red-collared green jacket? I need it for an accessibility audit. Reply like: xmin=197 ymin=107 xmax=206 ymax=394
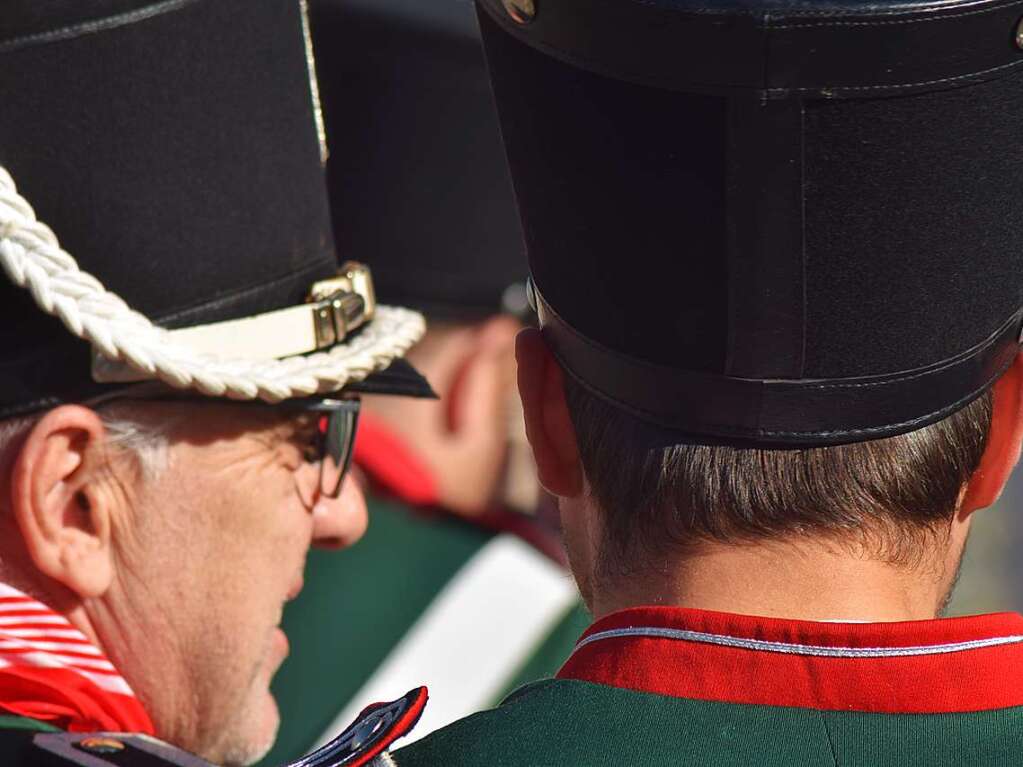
xmin=392 ymin=0 xmax=1023 ymax=767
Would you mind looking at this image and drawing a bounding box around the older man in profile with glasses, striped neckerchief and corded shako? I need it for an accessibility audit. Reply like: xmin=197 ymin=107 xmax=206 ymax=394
xmin=0 ymin=0 xmax=431 ymax=767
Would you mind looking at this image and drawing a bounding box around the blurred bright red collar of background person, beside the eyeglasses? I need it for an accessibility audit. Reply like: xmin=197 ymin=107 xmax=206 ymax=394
xmin=352 ymin=408 xmax=440 ymax=506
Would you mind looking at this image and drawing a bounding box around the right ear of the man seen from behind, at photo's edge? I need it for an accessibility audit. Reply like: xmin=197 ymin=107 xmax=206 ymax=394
xmin=960 ymin=354 xmax=1023 ymax=516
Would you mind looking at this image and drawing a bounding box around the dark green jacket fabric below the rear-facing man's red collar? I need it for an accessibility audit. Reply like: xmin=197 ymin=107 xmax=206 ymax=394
xmin=392 ymin=680 xmax=1023 ymax=767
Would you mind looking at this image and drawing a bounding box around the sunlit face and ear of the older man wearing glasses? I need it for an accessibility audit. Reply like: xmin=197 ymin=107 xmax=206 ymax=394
xmin=0 ymin=403 xmax=367 ymax=764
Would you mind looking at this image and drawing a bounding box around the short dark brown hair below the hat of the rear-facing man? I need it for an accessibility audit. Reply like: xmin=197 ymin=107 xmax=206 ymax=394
xmin=565 ymin=373 xmax=991 ymax=567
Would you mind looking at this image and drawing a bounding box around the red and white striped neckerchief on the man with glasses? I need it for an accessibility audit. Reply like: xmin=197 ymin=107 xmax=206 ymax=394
xmin=0 ymin=584 xmax=154 ymax=735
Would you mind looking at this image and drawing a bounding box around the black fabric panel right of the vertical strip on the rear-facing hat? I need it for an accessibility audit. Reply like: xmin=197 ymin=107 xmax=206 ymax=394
xmin=805 ymin=68 xmax=1023 ymax=377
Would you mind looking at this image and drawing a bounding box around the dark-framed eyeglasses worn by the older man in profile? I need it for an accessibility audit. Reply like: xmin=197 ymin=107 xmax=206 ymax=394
xmin=82 ymin=384 xmax=362 ymax=499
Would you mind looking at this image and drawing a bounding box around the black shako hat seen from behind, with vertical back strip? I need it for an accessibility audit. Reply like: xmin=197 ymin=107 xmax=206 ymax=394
xmin=478 ymin=0 xmax=1023 ymax=446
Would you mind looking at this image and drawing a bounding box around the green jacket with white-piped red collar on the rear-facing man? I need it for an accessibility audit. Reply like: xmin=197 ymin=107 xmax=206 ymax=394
xmin=392 ymin=608 xmax=1023 ymax=767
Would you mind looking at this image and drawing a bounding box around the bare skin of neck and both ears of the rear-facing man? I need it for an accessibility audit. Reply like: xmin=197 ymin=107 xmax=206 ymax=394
xmin=516 ymin=329 xmax=1023 ymax=621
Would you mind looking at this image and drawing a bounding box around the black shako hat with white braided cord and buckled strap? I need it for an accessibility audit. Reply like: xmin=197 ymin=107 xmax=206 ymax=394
xmin=0 ymin=0 xmax=430 ymax=417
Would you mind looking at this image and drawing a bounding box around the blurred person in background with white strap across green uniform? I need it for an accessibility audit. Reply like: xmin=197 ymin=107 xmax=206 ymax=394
xmin=259 ymin=0 xmax=588 ymax=764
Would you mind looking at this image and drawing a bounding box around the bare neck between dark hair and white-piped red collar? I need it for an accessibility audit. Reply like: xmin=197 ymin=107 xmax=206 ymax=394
xmin=590 ymin=539 xmax=962 ymax=622
